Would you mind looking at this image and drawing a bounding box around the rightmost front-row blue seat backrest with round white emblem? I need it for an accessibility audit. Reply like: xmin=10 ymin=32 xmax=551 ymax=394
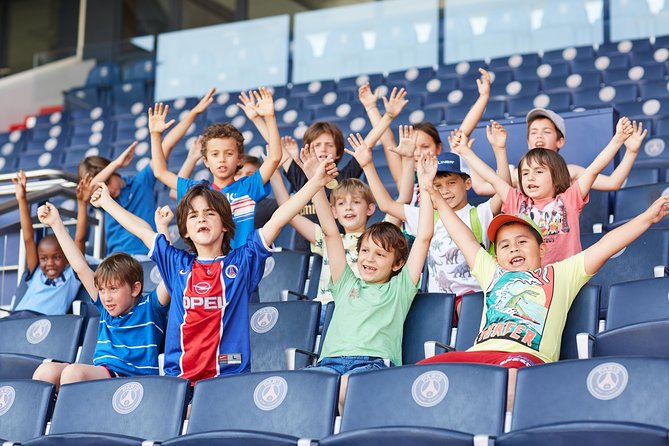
xmin=511 ymin=357 xmax=669 ymax=430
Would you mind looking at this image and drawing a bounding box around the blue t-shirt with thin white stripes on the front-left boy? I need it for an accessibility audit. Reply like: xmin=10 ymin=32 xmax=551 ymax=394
xmin=93 ymin=290 xmax=168 ymax=376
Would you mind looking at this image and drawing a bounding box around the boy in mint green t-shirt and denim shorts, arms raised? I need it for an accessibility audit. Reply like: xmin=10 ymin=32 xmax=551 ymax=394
xmin=315 ymin=146 xmax=437 ymax=413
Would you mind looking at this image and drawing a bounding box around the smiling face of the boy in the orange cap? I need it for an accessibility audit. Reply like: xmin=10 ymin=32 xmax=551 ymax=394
xmin=495 ymin=223 xmax=546 ymax=271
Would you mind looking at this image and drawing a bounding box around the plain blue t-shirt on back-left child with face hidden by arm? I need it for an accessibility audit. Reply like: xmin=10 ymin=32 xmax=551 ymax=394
xmin=105 ymin=164 xmax=156 ymax=255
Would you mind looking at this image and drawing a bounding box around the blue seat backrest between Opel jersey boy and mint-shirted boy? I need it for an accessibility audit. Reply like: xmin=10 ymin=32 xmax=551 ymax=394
xmin=249 ymin=301 xmax=321 ymax=372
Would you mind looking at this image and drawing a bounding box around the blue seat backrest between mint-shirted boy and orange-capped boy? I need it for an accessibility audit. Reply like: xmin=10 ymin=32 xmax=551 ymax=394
xmin=402 ymin=293 xmax=454 ymax=364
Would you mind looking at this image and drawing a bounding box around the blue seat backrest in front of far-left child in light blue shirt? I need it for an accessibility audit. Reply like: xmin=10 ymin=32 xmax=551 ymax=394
xmin=0 ymin=315 xmax=84 ymax=362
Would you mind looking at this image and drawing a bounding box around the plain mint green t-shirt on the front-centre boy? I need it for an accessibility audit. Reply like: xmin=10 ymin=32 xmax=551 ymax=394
xmin=319 ymin=265 xmax=418 ymax=365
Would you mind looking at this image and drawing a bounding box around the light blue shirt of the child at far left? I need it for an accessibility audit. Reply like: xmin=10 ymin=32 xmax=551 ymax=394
xmin=14 ymin=265 xmax=81 ymax=316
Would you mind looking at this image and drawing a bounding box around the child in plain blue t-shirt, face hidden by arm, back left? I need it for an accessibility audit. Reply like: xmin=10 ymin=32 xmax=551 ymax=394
xmin=79 ymin=88 xmax=216 ymax=258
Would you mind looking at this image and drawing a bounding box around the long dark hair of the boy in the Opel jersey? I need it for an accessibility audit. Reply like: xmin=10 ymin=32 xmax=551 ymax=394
xmin=177 ymin=183 xmax=235 ymax=255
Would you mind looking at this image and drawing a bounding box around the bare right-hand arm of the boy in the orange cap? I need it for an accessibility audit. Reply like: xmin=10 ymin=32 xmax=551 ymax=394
xmin=583 ymin=196 xmax=669 ymax=274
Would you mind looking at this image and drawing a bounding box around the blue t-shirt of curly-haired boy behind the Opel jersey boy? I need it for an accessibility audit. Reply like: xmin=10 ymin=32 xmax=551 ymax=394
xmin=177 ymin=170 xmax=270 ymax=249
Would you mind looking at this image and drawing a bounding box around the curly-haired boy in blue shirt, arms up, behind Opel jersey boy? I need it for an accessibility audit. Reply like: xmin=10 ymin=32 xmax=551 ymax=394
xmin=149 ymin=88 xmax=281 ymax=248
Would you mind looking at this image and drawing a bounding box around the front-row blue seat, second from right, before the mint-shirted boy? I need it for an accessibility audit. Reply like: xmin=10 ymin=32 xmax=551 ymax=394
xmin=319 ymin=363 xmax=507 ymax=446
